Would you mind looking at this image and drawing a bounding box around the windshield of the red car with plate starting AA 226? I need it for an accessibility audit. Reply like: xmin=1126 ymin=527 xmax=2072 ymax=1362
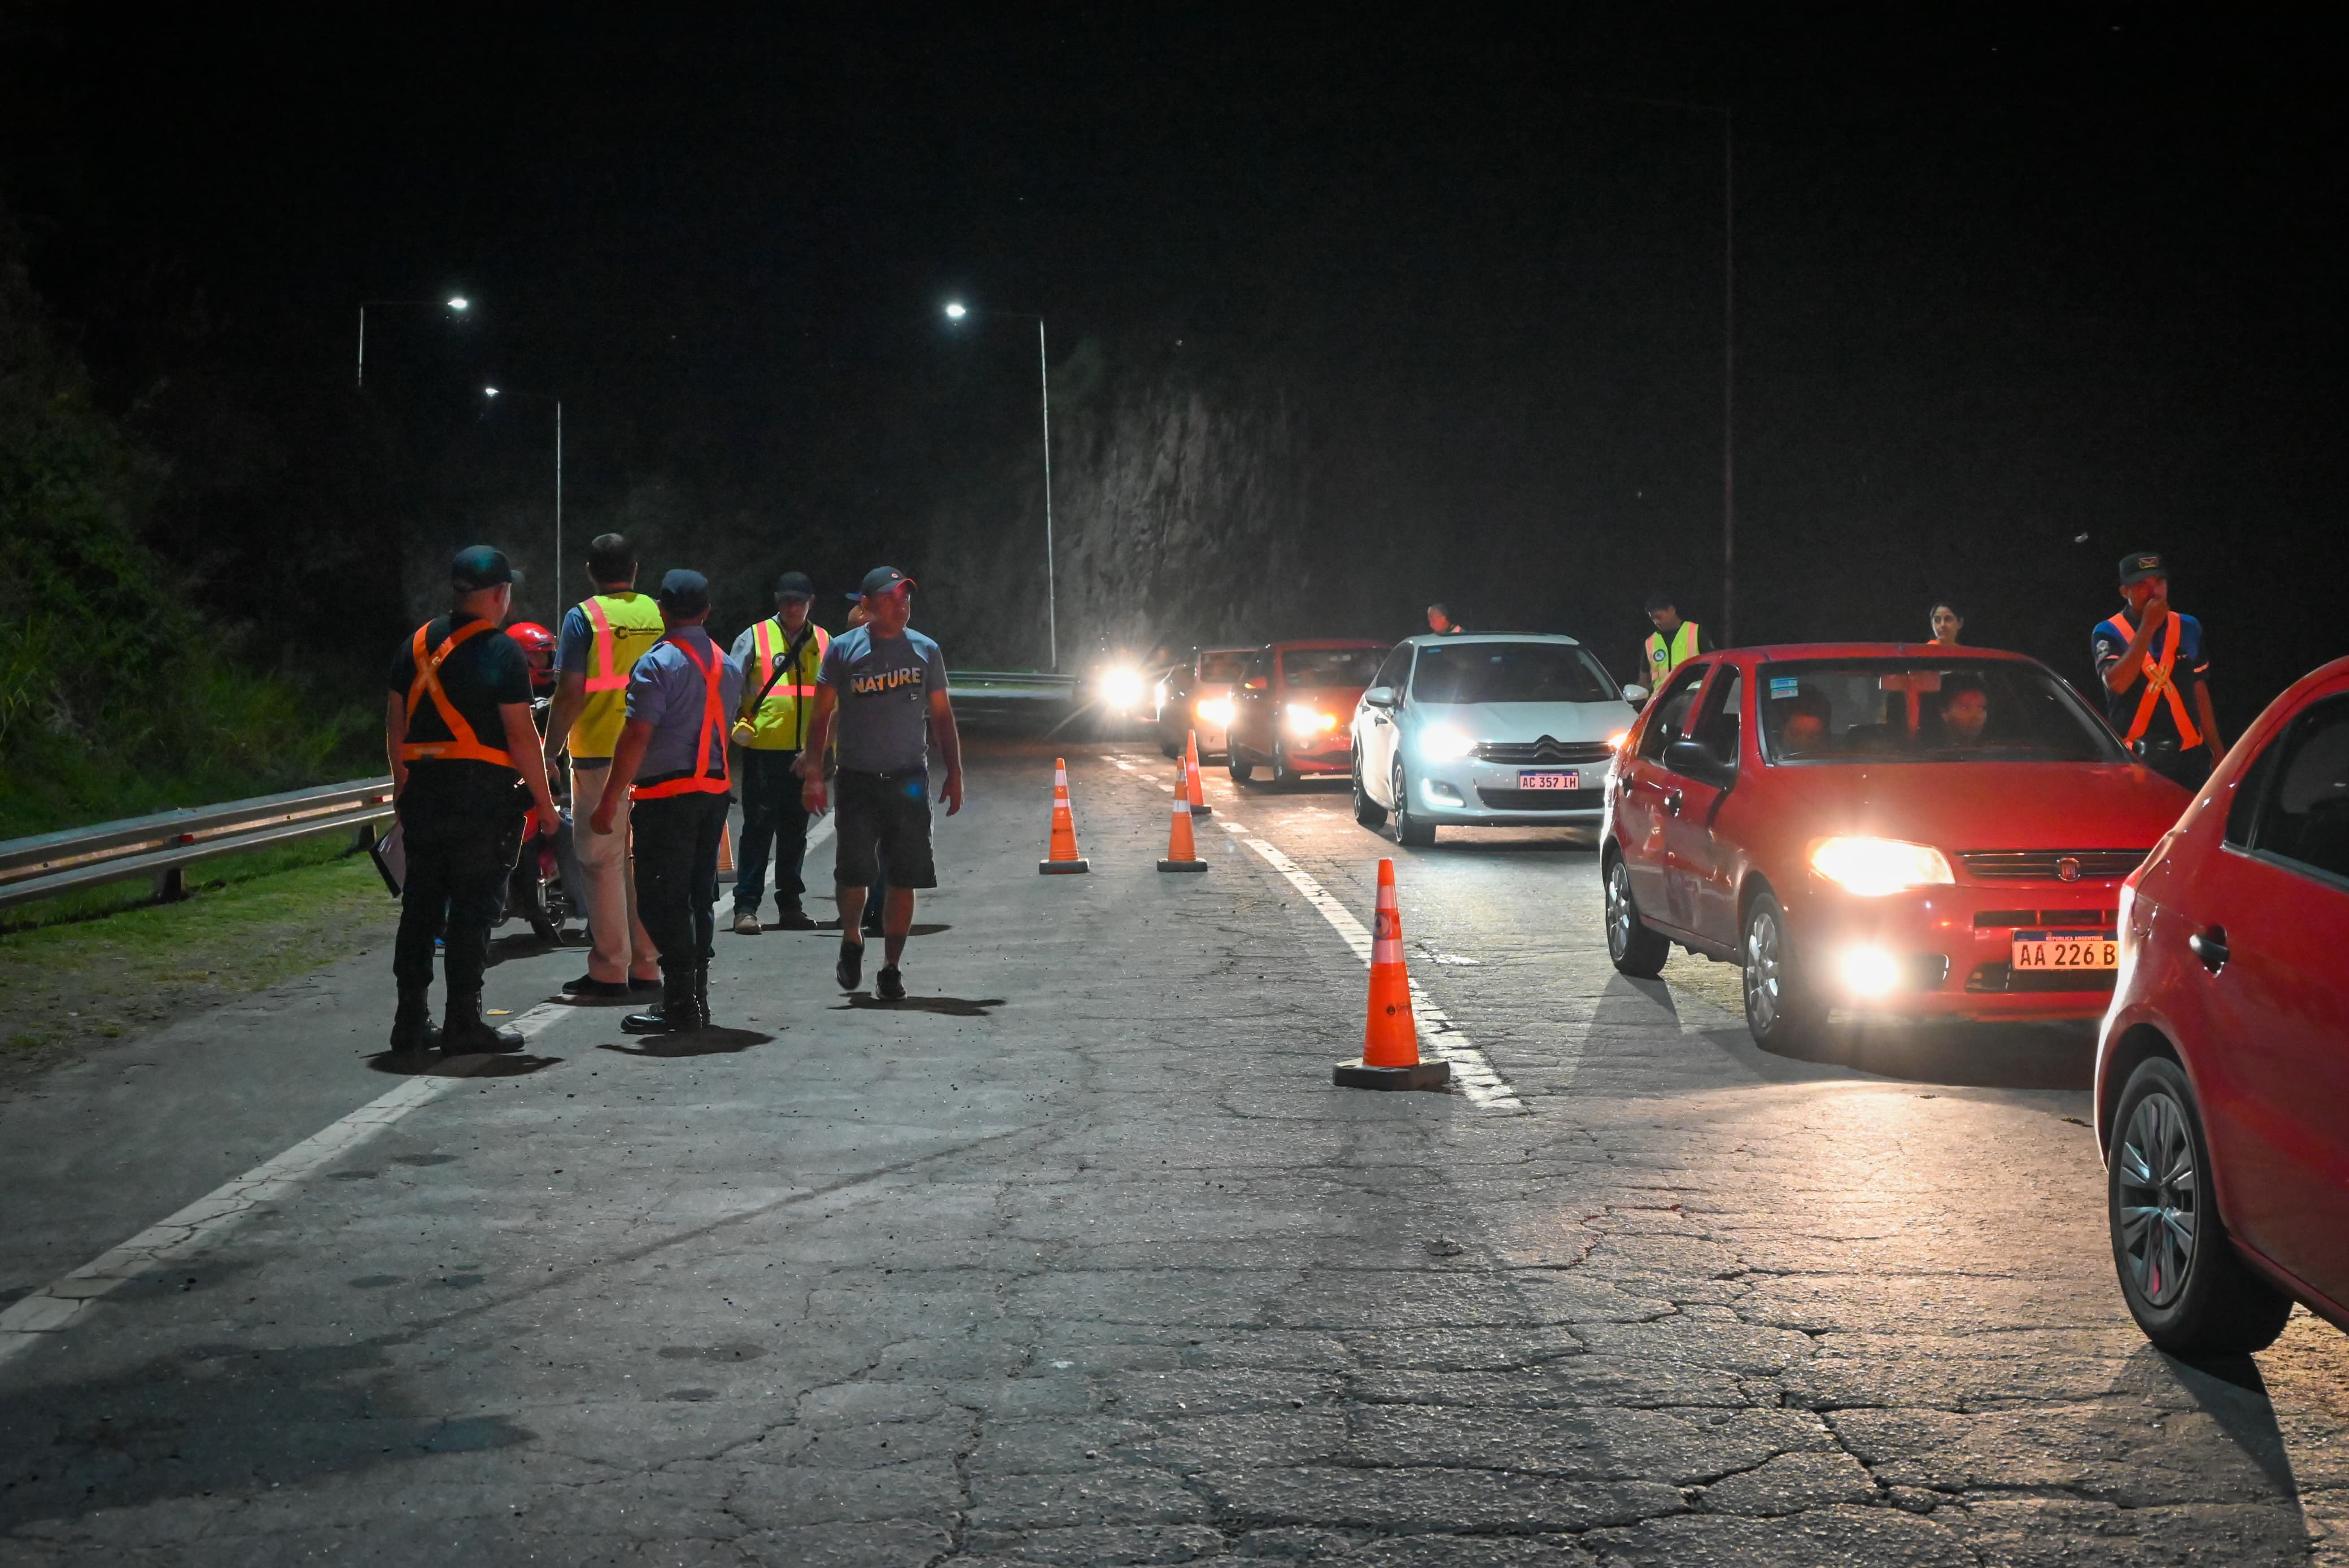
xmin=1755 ymin=659 xmax=2128 ymax=763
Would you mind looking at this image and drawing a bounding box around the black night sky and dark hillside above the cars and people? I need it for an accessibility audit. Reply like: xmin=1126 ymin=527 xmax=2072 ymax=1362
xmin=0 ymin=5 xmax=2349 ymax=713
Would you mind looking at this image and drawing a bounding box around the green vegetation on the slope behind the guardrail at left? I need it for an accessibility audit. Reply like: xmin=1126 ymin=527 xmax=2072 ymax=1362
xmin=0 ymin=226 xmax=381 ymax=838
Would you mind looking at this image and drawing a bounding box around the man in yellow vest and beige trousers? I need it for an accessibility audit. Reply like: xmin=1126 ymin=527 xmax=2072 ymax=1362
xmin=547 ymin=533 xmax=660 ymax=998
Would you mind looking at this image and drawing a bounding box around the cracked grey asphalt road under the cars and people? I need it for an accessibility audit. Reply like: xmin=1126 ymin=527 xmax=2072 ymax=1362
xmin=0 ymin=746 xmax=2349 ymax=1568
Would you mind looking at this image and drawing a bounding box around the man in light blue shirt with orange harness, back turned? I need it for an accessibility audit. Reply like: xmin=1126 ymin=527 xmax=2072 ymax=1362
xmin=587 ymin=570 xmax=743 ymax=1035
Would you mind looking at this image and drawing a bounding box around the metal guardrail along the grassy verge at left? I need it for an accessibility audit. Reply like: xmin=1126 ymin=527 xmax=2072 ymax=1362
xmin=0 ymin=775 xmax=392 ymax=909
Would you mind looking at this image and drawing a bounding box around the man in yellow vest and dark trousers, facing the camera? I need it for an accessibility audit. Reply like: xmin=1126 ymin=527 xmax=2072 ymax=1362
xmin=731 ymin=573 xmax=832 ymax=937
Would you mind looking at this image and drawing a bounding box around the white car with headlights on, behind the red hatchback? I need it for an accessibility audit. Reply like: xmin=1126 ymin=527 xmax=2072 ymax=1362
xmin=1353 ymin=631 xmax=1647 ymax=845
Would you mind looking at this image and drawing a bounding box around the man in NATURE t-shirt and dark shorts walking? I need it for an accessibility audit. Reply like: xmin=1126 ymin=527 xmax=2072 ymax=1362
xmin=798 ymin=566 xmax=963 ymax=1002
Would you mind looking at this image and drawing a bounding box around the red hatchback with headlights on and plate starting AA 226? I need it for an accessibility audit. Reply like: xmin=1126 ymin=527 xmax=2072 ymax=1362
xmin=1600 ymin=643 xmax=2187 ymax=1047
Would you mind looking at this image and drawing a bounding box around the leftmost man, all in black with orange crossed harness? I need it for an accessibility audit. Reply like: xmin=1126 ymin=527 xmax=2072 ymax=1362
xmin=383 ymin=544 xmax=557 ymax=1054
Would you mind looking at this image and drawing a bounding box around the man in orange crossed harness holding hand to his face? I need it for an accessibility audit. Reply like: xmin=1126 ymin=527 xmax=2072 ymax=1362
xmin=2088 ymin=549 xmax=2227 ymax=789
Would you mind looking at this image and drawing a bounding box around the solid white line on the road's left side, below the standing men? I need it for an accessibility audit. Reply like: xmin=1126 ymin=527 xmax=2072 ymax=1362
xmin=0 ymin=1002 xmax=571 ymax=1364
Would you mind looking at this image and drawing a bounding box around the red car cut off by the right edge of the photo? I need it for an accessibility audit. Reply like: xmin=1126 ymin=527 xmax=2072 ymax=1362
xmin=2095 ymin=659 xmax=2349 ymax=1355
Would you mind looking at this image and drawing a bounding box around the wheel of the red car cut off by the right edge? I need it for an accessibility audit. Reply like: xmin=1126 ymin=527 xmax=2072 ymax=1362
xmin=2105 ymin=1056 xmax=2293 ymax=1357
